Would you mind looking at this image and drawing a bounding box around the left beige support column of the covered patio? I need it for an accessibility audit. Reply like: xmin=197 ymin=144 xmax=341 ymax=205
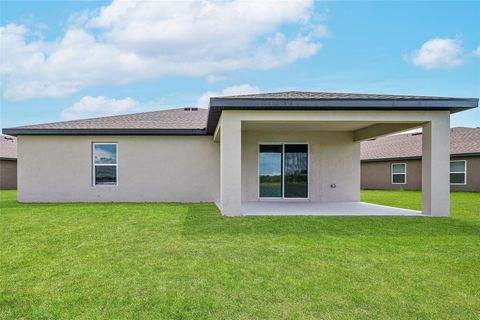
xmin=220 ymin=111 xmax=242 ymax=217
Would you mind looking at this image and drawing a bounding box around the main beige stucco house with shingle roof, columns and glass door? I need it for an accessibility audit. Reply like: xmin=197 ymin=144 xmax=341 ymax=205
xmin=3 ymin=92 xmax=478 ymax=216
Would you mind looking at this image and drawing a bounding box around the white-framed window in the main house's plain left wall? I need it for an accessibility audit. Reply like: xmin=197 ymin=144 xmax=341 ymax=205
xmin=93 ymin=143 xmax=118 ymax=186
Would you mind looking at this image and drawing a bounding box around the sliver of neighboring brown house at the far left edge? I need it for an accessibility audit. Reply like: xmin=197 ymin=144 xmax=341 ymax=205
xmin=0 ymin=135 xmax=17 ymax=190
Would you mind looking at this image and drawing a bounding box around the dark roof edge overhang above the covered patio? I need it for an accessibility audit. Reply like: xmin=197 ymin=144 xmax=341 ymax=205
xmin=207 ymin=97 xmax=478 ymax=134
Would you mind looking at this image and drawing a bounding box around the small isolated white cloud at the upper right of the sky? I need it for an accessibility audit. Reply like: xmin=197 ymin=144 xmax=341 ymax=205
xmin=411 ymin=38 xmax=464 ymax=70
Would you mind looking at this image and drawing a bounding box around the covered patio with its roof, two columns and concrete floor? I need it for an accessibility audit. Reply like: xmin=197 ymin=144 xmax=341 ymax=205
xmin=207 ymin=92 xmax=476 ymax=216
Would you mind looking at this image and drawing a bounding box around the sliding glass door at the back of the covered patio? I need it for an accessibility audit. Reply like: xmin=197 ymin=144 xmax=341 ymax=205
xmin=259 ymin=144 xmax=308 ymax=198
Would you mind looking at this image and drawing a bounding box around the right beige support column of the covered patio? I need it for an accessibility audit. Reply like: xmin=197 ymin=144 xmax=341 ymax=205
xmin=422 ymin=115 xmax=450 ymax=217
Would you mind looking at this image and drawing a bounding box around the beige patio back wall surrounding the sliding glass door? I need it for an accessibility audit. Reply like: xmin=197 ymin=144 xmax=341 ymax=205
xmin=242 ymin=131 xmax=360 ymax=201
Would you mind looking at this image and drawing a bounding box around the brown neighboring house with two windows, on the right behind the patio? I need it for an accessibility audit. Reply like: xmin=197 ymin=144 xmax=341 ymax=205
xmin=361 ymin=127 xmax=480 ymax=191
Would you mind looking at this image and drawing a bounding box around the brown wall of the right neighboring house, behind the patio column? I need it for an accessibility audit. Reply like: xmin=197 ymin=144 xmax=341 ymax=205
xmin=361 ymin=157 xmax=480 ymax=192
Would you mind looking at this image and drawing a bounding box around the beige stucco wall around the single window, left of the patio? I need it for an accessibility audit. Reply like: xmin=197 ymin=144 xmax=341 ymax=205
xmin=18 ymin=136 xmax=220 ymax=202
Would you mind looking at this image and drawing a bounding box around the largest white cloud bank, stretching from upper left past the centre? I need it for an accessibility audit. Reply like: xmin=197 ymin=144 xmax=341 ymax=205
xmin=0 ymin=0 xmax=326 ymax=100
